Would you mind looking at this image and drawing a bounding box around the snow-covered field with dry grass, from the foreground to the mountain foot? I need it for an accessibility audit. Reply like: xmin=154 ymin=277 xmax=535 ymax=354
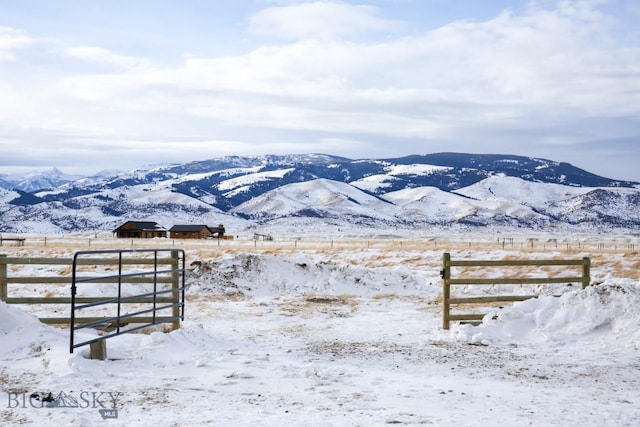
xmin=0 ymin=231 xmax=640 ymax=427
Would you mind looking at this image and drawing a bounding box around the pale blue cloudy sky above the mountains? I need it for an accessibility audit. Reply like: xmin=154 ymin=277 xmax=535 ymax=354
xmin=0 ymin=0 xmax=640 ymax=181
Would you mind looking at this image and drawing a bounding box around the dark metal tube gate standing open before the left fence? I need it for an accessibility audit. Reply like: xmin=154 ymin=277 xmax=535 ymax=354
xmin=69 ymin=249 xmax=185 ymax=353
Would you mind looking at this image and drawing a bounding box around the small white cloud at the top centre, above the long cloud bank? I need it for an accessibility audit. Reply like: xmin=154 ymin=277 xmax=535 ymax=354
xmin=249 ymin=2 xmax=402 ymax=39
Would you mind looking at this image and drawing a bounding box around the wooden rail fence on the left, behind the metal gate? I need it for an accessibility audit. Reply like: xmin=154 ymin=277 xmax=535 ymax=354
xmin=0 ymin=251 xmax=185 ymax=329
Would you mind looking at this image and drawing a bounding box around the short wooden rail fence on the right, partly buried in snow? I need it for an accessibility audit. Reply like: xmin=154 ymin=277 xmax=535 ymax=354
xmin=441 ymin=253 xmax=591 ymax=329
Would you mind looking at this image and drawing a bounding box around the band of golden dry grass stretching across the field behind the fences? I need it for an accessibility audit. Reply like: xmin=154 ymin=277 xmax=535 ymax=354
xmin=1 ymin=238 xmax=640 ymax=277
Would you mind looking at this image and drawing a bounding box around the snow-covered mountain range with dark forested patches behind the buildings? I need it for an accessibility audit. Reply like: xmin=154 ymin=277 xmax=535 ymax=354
xmin=0 ymin=153 xmax=640 ymax=232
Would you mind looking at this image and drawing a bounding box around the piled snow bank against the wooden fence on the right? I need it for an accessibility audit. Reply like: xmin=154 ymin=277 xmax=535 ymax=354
xmin=452 ymin=279 xmax=640 ymax=349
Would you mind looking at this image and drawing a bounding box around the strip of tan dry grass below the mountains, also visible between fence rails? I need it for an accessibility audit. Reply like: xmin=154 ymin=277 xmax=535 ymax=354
xmin=0 ymin=234 xmax=640 ymax=298
